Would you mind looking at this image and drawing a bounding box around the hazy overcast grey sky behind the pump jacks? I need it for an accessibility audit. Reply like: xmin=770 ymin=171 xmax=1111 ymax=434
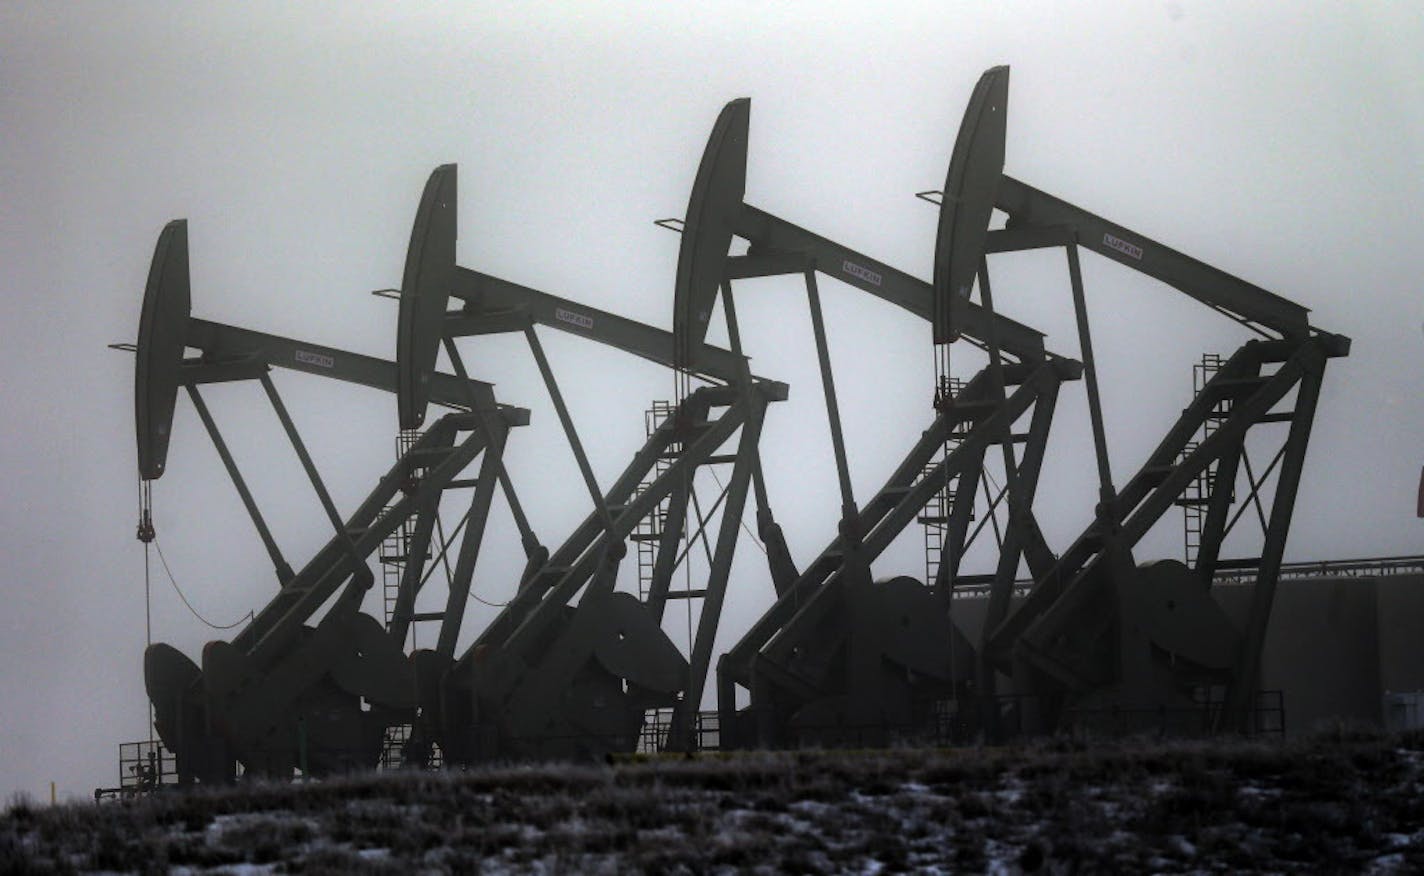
xmin=0 ymin=1 xmax=1424 ymax=796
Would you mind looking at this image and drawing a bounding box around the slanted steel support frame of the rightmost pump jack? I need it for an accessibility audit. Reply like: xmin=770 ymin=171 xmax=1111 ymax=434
xmin=988 ymin=335 xmax=1349 ymax=729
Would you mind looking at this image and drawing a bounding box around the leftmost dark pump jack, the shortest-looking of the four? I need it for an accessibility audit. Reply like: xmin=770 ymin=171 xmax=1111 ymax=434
xmin=126 ymin=219 xmax=528 ymax=782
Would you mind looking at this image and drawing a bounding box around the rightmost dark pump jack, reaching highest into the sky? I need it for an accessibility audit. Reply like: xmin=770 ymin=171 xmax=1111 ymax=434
xmin=934 ymin=67 xmax=1350 ymax=732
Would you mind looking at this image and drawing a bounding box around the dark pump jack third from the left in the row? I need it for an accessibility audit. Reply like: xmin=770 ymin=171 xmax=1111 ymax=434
xmin=660 ymin=100 xmax=1081 ymax=746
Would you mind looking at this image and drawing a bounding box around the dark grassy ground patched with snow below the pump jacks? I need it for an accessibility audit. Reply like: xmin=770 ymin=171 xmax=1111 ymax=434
xmin=0 ymin=731 xmax=1424 ymax=873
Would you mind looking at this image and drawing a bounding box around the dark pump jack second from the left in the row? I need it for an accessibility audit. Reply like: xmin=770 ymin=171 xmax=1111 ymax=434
xmin=384 ymin=165 xmax=790 ymax=763
